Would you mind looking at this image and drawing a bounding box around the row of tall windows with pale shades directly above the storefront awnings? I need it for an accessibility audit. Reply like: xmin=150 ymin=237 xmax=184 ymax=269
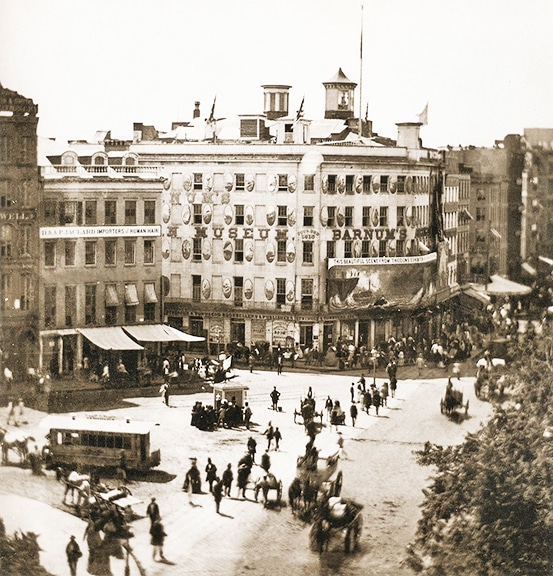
xmin=44 ymin=283 xmax=157 ymax=328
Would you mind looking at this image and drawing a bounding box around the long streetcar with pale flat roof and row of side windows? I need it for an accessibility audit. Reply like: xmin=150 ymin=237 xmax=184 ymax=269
xmin=44 ymin=416 xmax=161 ymax=470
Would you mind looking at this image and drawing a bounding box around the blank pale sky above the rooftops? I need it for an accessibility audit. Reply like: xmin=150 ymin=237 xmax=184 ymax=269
xmin=0 ymin=0 xmax=553 ymax=147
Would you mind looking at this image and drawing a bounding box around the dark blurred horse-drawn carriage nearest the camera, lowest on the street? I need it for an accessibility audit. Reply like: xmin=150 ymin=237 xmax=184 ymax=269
xmin=309 ymin=496 xmax=363 ymax=554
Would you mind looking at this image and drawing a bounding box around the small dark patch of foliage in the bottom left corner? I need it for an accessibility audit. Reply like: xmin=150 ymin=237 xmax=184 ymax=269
xmin=0 ymin=518 xmax=52 ymax=576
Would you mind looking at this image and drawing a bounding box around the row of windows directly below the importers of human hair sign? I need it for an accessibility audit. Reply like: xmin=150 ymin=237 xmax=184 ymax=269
xmin=44 ymin=238 xmax=155 ymax=267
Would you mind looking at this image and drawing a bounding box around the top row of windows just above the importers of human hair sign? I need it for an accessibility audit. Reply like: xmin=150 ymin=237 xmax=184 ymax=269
xmin=44 ymin=199 xmax=156 ymax=226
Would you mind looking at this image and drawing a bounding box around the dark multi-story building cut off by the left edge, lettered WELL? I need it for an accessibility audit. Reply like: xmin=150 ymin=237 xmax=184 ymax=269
xmin=0 ymin=85 xmax=39 ymax=378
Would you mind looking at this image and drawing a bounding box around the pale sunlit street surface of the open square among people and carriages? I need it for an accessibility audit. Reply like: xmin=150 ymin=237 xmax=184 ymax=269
xmin=0 ymin=370 xmax=491 ymax=576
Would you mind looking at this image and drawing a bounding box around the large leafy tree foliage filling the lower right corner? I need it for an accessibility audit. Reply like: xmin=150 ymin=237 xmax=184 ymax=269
xmin=410 ymin=326 xmax=553 ymax=576
